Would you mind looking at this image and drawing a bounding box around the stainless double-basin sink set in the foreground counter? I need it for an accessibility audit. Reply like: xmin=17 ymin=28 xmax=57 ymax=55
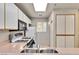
xmin=21 ymin=48 xmax=58 ymax=53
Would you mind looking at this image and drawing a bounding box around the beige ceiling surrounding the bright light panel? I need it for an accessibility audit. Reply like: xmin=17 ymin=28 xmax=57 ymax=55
xmin=16 ymin=3 xmax=79 ymax=18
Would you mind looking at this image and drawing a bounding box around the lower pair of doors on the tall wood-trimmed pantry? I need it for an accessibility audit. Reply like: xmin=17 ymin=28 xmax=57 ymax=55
xmin=57 ymin=36 xmax=74 ymax=48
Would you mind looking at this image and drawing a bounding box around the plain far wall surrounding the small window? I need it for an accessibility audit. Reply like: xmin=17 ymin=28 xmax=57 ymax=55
xmin=32 ymin=18 xmax=49 ymax=47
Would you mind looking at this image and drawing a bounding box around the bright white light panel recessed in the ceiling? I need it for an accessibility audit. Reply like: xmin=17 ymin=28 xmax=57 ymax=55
xmin=34 ymin=0 xmax=47 ymax=11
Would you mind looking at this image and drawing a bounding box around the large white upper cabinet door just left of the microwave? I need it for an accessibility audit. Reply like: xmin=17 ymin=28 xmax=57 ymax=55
xmin=6 ymin=3 xmax=18 ymax=30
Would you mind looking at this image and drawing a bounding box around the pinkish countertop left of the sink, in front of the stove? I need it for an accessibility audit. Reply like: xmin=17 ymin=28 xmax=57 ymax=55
xmin=0 ymin=40 xmax=26 ymax=54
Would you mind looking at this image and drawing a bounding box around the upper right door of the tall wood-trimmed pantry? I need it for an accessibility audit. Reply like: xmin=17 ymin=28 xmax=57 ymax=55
xmin=66 ymin=15 xmax=74 ymax=34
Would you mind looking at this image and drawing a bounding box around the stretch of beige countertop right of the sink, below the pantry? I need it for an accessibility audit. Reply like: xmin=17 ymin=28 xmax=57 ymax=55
xmin=56 ymin=48 xmax=79 ymax=55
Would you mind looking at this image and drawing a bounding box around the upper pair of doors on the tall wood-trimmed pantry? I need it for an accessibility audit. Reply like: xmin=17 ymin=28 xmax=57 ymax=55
xmin=56 ymin=14 xmax=75 ymax=34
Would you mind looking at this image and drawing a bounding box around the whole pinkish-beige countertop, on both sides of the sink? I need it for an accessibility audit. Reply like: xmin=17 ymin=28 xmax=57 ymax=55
xmin=0 ymin=40 xmax=79 ymax=55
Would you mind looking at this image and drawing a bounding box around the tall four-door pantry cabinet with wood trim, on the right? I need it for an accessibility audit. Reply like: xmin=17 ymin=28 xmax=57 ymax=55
xmin=56 ymin=15 xmax=75 ymax=48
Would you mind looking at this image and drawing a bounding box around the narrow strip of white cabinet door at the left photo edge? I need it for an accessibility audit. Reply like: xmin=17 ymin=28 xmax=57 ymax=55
xmin=0 ymin=3 xmax=4 ymax=29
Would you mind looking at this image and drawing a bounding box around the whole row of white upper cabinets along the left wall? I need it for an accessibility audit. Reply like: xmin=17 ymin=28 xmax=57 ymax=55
xmin=0 ymin=3 xmax=31 ymax=30
